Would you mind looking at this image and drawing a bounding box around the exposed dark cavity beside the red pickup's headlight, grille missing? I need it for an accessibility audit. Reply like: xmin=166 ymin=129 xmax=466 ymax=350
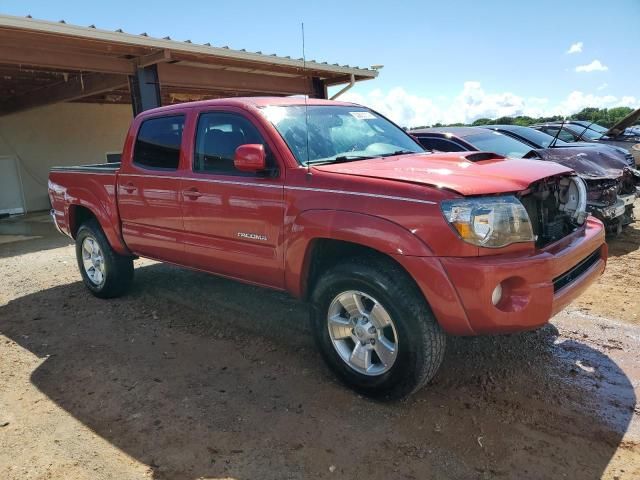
xmin=520 ymin=175 xmax=587 ymax=248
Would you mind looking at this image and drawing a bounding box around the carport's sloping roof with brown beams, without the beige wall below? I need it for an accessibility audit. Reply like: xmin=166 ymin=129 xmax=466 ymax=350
xmin=0 ymin=16 xmax=377 ymax=115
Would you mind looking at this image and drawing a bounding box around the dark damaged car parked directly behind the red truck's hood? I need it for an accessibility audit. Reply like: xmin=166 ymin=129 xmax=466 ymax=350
xmin=411 ymin=127 xmax=639 ymax=233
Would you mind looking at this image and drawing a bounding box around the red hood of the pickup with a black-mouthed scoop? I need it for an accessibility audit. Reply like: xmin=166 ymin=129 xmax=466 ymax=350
xmin=314 ymin=152 xmax=571 ymax=195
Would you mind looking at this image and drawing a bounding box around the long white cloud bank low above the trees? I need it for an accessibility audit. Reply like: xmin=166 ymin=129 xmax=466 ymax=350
xmin=340 ymin=81 xmax=640 ymax=127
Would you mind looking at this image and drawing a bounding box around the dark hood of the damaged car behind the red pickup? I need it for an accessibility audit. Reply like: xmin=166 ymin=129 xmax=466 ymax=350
xmin=535 ymin=146 xmax=627 ymax=179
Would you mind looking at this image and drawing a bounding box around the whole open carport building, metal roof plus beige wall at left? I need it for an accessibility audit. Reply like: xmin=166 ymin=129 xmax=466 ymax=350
xmin=0 ymin=15 xmax=377 ymax=213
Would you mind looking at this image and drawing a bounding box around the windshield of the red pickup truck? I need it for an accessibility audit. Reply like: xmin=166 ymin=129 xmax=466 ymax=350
xmin=261 ymin=105 xmax=424 ymax=165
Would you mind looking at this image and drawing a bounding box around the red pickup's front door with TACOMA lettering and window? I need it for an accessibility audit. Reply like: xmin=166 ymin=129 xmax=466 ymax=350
xmin=182 ymin=109 xmax=284 ymax=288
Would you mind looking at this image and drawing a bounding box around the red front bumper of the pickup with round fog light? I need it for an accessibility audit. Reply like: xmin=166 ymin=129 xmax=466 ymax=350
xmin=404 ymin=217 xmax=607 ymax=335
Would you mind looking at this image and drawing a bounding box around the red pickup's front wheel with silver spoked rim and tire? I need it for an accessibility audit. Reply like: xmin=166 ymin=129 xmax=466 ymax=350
xmin=312 ymin=258 xmax=446 ymax=398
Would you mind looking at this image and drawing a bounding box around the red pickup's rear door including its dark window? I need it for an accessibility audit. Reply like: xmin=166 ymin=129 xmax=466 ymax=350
xmin=117 ymin=112 xmax=186 ymax=264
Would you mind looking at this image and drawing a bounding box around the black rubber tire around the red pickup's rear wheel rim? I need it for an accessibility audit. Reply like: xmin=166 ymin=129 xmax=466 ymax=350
xmin=76 ymin=219 xmax=133 ymax=298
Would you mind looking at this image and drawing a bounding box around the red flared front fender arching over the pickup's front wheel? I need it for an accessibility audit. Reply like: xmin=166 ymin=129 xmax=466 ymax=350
xmin=285 ymin=210 xmax=433 ymax=297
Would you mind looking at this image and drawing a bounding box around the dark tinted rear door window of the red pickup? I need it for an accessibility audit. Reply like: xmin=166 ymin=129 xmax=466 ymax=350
xmin=133 ymin=115 xmax=185 ymax=170
